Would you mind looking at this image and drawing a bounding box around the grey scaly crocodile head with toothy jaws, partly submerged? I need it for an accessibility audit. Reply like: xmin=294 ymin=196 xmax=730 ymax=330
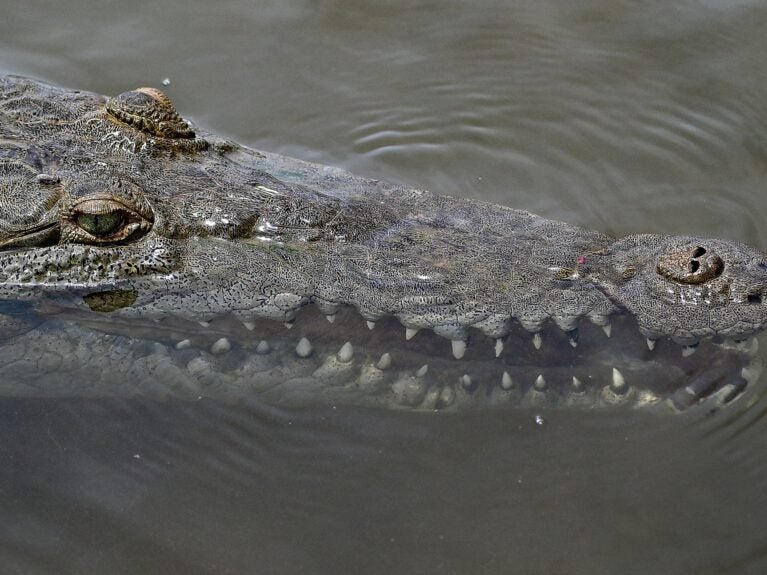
xmin=0 ymin=76 xmax=767 ymax=411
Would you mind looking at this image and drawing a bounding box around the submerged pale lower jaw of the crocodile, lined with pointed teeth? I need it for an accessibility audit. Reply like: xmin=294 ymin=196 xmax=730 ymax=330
xmin=0 ymin=309 xmax=761 ymax=411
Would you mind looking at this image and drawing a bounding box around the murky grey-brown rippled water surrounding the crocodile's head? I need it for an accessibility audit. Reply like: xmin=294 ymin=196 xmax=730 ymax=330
xmin=0 ymin=0 xmax=767 ymax=575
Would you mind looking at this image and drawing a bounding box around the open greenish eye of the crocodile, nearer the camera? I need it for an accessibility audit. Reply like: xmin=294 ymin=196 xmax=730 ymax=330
xmin=62 ymin=198 xmax=152 ymax=244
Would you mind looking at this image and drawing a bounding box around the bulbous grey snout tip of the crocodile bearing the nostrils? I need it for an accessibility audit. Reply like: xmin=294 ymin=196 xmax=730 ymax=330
xmin=587 ymin=235 xmax=767 ymax=345
